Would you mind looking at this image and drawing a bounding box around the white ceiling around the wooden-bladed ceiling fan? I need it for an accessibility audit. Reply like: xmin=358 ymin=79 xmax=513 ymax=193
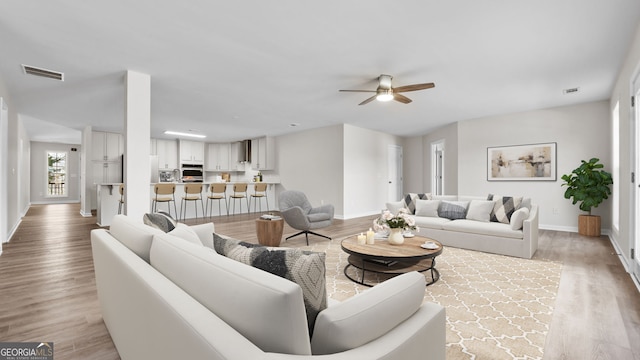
xmin=0 ymin=0 xmax=640 ymax=142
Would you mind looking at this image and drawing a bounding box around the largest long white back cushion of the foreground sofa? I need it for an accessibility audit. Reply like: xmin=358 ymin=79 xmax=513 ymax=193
xmin=151 ymin=233 xmax=311 ymax=355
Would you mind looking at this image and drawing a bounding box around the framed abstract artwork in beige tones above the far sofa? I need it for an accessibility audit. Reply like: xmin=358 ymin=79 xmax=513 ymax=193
xmin=487 ymin=142 xmax=557 ymax=181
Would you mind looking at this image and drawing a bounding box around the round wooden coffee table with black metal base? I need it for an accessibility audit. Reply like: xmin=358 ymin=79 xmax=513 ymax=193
xmin=340 ymin=235 xmax=443 ymax=286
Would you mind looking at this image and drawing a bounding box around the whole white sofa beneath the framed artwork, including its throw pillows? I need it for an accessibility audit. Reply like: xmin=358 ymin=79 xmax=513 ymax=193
xmin=387 ymin=193 xmax=538 ymax=259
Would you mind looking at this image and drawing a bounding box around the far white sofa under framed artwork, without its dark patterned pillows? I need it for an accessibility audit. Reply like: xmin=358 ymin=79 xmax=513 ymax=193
xmin=387 ymin=194 xmax=538 ymax=259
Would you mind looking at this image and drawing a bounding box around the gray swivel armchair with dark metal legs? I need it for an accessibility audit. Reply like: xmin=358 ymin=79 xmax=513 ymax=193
xmin=278 ymin=190 xmax=334 ymax=245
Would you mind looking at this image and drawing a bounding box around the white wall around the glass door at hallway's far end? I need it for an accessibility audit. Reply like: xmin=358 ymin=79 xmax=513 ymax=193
xmin=30 ymin=141 xmax=80 ymax=204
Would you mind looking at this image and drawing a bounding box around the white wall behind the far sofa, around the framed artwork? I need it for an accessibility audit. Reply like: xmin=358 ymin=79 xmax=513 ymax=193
xmin=458 ymin=101 xmax=611 ymax=231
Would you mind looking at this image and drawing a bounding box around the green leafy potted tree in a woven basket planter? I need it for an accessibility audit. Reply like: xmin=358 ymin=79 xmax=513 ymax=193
xmin=562 ymin=158 xmax=613 ymax=236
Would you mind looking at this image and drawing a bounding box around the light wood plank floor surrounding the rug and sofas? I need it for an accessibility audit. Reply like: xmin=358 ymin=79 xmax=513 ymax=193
xmin=0 ymin=204 xmax=640 ymax=360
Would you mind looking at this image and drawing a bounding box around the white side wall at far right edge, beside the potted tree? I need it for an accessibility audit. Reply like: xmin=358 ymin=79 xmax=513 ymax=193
xmin=609 ymin=21 xmax=640 ymax=263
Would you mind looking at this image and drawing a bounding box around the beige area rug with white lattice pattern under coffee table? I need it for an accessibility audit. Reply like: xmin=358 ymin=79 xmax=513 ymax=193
xmin=296 ymin=239 xmax=562 ymax=360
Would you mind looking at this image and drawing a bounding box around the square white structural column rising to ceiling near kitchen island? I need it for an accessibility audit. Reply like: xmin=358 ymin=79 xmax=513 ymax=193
xmin=124 ymin=71 xmax=151 ymax=220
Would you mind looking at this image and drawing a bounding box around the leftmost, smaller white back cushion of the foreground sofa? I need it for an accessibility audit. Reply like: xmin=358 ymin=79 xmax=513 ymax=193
xmin=109 ymin=215 xmax=164 ymax=262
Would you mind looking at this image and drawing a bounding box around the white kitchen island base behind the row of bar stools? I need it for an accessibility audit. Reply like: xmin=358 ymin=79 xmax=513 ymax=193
xmin=96 ymin=180 xmax=280 ymax=227
